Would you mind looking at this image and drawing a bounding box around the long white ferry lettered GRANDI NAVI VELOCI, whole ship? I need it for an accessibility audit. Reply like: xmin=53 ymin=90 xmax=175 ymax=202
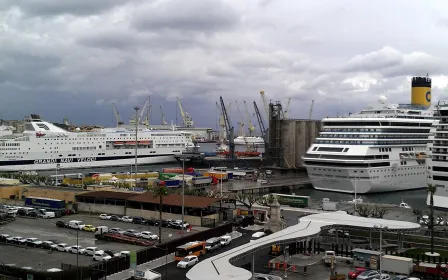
xmin=0 ymin=115 xmax=191 ymax=171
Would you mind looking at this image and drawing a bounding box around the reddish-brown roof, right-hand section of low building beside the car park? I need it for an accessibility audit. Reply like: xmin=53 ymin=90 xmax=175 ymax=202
xmin=128 ymin=192 xmax=219 ymax=208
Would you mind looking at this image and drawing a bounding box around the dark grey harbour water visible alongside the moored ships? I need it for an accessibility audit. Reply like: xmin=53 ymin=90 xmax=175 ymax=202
xmin=38 ymin=143 xmax=427 ymax=209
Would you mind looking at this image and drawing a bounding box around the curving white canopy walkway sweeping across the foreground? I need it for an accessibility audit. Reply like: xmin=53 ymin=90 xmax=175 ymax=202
xmin=187 ymin=211 xmax=420 ymax=280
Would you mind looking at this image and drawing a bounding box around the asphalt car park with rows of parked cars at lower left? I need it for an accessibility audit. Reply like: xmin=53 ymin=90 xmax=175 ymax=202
xmin=0 ymin=214 xmax=206 ymax=269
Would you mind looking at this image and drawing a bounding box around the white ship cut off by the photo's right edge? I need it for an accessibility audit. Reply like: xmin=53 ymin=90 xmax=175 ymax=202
xmin=426 ymin=101 xmax=448 ymax=208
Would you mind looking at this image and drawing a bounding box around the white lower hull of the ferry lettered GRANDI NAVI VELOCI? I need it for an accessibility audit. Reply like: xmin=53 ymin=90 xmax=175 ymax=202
xmin=0 ymin=154 xmax=176 ymax=172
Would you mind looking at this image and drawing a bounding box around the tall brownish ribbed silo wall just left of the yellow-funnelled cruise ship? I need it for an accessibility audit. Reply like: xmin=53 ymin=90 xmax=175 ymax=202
xmin=281 ymin=120 xmax=321 ymax=168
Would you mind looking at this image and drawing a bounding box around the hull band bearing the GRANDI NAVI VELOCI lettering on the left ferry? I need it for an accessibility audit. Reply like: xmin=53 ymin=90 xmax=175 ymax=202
xmin=0 ymin=155 xmax=176 ymax=172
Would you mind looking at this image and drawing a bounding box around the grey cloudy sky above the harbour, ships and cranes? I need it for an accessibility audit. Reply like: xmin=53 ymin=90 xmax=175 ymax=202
xmin=0 ymin=0 xmax=448 ymax=131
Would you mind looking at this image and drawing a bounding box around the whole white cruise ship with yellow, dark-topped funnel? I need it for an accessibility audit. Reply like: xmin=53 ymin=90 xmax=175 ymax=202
xmin=303 ymin=78 xmax=432 ymax=193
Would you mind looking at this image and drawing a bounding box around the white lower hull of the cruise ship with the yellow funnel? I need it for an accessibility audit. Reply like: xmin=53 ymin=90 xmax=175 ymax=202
xmin=310 ymin=175 xmax=428 ymax=192
